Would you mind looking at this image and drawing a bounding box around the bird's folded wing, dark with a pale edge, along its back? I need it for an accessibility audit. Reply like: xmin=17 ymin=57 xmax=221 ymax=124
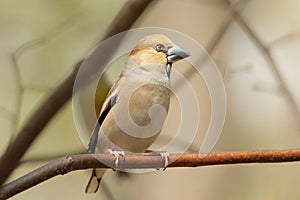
xmin=88 ymin=74 xmax=123 ymax=154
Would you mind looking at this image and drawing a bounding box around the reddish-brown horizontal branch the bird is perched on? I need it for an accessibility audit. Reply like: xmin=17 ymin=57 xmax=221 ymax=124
xmin=0 ymin=149 xmax=300 ymax=199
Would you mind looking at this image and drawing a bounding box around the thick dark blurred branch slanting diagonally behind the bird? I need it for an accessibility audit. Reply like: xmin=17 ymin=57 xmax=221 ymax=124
xmin=0 ymin=0 xmax=151 ymax=185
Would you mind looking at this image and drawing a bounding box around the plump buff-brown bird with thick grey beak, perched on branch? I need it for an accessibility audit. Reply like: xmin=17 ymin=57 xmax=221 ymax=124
xmin=85 ymin=34 xmax=190 ymax=193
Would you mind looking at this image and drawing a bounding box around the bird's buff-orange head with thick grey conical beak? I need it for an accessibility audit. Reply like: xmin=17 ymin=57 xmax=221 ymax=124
xmin=125 ymin=34 xmax=190 ymax=76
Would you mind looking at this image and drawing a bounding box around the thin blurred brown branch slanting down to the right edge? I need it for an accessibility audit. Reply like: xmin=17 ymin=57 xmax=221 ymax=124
xmin=226 ymin=0 xmax=300 ymax=128
